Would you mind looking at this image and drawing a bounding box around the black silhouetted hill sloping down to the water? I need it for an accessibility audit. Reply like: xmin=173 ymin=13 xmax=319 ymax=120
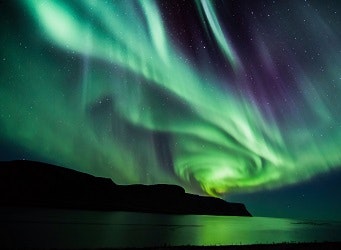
xmin=0 ymin=161 xmax=251 ymax=216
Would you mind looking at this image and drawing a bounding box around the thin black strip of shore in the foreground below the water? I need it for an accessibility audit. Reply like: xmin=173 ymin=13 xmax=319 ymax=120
xmin=2 ymin=242 xmax=341 ymax=250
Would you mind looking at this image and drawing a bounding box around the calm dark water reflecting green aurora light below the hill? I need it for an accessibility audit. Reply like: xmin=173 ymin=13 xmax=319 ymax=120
xmin=0 ymin=208 xmax=341 ymax=248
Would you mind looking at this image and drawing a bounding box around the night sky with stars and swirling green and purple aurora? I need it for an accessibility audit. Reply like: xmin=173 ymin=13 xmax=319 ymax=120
xmin=0 ymin=0 xmax=341 ymax=220
